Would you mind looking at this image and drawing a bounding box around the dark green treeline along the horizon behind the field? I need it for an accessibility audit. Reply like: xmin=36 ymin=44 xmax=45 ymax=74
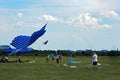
xmin=0 ymin=50 xmax=120 ymax=57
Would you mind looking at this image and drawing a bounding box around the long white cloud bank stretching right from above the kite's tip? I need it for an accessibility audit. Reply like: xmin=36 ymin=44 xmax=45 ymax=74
xmin=38 ymin=13 xmax=112 ymax=30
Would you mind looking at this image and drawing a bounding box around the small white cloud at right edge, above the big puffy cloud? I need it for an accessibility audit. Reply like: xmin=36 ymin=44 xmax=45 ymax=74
xmin=100 ymin=10 xmax=120 ymax=19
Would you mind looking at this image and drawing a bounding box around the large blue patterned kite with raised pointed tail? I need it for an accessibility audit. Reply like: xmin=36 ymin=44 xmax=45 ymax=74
xmin=10 ymin=24 xmax=47 ymax=55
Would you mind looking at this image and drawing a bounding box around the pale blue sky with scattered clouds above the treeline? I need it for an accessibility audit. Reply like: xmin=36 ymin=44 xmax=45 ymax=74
xmin=0 ymin=0 xmax=120 ymax=50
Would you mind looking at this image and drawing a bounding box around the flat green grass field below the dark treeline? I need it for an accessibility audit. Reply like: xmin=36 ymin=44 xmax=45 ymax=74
xmin=0 ymin=57 xmax=120 ymax=80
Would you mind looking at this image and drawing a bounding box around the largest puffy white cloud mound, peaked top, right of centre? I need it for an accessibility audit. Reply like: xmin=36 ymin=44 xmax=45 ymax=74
xmin=67 ymin=13 xmax=112 ymax=30
